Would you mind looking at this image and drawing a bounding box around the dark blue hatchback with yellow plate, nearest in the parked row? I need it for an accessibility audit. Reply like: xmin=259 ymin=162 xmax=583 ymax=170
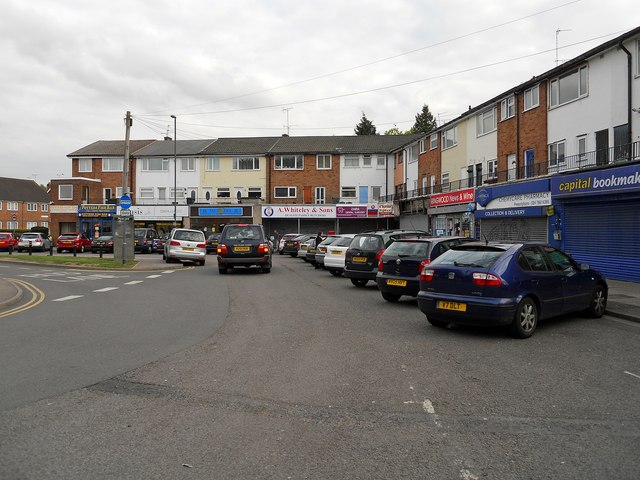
xmin=418 ymin=242 xmax=608 ymax=338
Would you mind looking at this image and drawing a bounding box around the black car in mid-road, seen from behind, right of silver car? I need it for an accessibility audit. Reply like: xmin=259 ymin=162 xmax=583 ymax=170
xmin=218 ymin=223 xmax=272 ymax=274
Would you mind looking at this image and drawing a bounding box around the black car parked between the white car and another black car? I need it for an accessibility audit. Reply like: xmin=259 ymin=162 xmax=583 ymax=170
xmin=344 ymin=230 xmax=428 ymax=287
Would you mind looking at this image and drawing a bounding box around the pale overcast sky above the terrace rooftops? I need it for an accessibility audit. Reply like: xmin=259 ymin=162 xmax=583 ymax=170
xmin=0 ymin=0 xmax=640 ymax=184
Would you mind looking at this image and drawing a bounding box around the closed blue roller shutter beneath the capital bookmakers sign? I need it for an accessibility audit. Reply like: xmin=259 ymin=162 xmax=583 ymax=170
xmin=564 ymin=201 xmax=640 ymax=282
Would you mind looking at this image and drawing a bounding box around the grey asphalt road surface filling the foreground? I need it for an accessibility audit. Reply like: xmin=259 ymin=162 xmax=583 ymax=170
xmin=0 ymin=253 xmax=640 ymax=480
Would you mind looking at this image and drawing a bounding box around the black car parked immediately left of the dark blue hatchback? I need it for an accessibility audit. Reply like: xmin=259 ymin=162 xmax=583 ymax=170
xmin=376 ymin=237 xmax=470 ymax=302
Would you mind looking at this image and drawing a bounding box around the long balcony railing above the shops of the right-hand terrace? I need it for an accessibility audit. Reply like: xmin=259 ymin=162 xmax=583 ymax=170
xmin=380 ymin=142 xmax=640 ymax=202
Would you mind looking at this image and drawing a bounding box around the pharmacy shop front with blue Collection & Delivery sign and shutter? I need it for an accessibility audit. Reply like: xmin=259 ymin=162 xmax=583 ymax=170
xmin=474 ymin=179 xmax=553 ymax=243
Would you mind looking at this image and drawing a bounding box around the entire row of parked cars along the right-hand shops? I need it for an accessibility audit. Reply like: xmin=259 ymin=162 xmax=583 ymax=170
xmin=285 ymin=230 xmax=608 ymax=338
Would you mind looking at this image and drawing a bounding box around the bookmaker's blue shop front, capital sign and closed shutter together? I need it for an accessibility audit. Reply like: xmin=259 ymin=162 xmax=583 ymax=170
xmin=551 ymin=163 xmax=640 ymax=282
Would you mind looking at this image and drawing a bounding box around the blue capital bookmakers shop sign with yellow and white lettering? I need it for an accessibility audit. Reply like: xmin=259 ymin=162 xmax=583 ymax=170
xmin=551 ymin=165 xmax=640 ymax=197
